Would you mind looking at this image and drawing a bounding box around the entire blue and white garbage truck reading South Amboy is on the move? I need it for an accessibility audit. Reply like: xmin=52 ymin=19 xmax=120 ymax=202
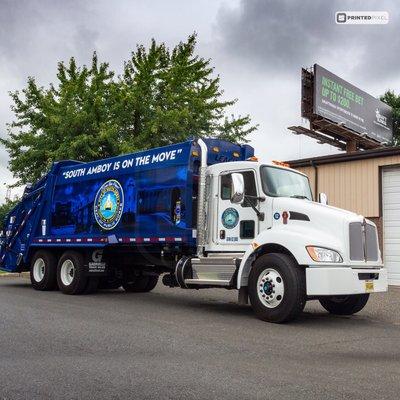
xmin=0 ymin=139 xmax=387 ymax=323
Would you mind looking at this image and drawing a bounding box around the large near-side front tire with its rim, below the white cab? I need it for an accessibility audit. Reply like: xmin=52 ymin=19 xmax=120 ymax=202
xmin=248 ymin=253 xmax=306 ymax=323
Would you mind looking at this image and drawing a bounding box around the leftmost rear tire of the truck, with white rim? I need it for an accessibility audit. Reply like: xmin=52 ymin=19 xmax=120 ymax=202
xmin=30 ymin=250 xmax=57 ymax=290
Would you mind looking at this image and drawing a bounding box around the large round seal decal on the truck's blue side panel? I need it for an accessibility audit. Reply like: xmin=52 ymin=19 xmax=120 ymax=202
xmin=94 ymin=179 xmax=124 ymax=230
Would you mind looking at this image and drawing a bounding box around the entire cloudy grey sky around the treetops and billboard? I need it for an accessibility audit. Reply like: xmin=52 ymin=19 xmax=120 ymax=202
xmin=0 ymin=0 xmax=400 ymax=203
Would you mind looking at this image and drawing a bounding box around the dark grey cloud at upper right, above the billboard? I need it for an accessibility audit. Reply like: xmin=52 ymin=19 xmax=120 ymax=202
xmin=217 ymin=0 xmax=400 ymax=81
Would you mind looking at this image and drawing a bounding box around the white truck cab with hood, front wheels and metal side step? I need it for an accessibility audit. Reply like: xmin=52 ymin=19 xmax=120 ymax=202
xmin=189 ymin=145 xmax=388 ymax=322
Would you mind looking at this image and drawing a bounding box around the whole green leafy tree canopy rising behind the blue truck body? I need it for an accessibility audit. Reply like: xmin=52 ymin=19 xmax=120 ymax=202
xmin=0 ymin=35 xmax=257 ymax=185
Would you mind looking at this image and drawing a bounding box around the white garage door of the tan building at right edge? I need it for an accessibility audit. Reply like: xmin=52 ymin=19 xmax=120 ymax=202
xmin=382 ymin=168 xmax=400 ymax=285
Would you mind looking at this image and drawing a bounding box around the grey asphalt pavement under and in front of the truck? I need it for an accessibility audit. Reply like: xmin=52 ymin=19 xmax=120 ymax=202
xmin=0 ymin=277 xmax=400 ymax=400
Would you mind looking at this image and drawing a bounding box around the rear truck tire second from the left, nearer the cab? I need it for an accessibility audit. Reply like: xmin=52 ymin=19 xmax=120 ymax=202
xmin=57 ymin=251 xmax=88 ymax=294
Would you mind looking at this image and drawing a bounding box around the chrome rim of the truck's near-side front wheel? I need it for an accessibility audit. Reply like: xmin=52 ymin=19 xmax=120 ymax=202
xmin=257 ymin=268 xmax=285 ymax=308
